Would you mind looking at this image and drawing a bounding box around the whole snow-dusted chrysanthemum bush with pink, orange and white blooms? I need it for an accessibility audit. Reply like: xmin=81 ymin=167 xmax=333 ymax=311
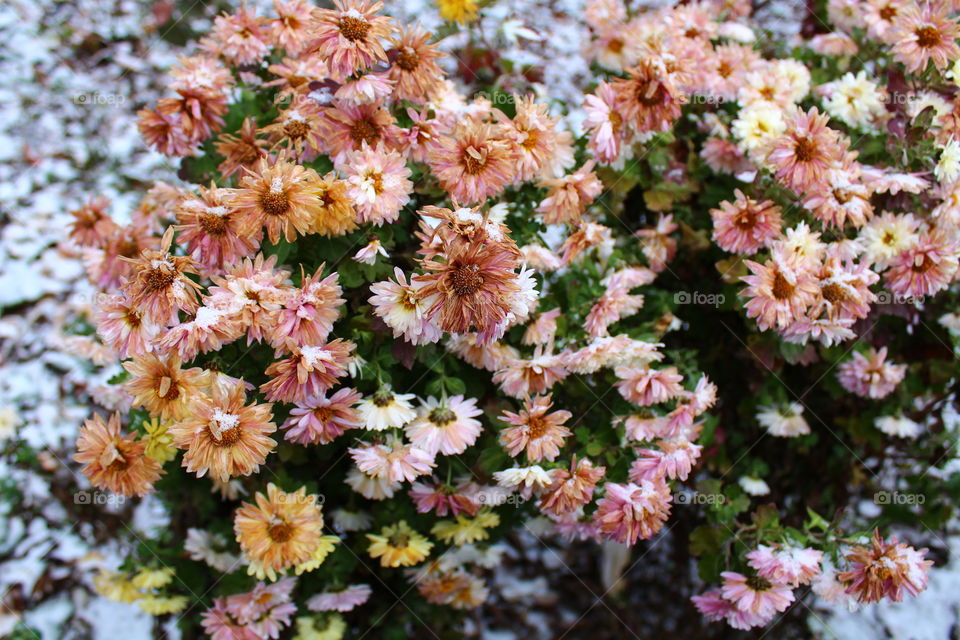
xmin=62 ymin=0 xmax=960 ymax=640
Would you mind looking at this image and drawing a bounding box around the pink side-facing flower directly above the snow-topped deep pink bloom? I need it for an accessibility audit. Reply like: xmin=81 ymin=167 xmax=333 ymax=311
xmin=270 ymin=265 xmax=346 ymax=349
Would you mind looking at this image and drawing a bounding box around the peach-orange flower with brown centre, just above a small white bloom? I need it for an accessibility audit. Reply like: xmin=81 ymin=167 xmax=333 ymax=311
xmin=500 ymin=395 xmax=573 ymax=462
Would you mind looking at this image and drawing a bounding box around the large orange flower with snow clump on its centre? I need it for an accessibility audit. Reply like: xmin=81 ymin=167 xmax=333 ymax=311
xmin=170 ymin=380 xmax=277 ymax=482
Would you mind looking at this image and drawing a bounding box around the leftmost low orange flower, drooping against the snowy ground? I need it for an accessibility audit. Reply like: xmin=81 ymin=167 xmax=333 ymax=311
xmin=73 ymin=413 xmax=161 ymax=496
